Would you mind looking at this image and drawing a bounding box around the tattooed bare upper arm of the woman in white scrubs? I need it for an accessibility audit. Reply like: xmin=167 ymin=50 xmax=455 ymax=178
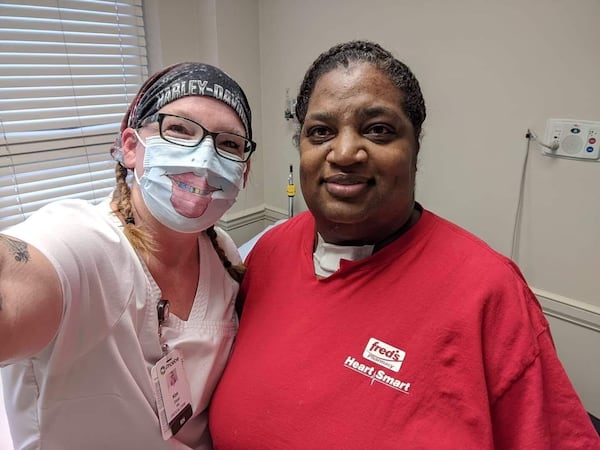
xmin=0 ymin=234 xmax=62 ymax=361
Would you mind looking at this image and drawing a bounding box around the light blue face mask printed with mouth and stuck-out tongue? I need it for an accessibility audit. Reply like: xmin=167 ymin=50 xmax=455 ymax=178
xmin=134 ymin=131 xmax=247 ymax=233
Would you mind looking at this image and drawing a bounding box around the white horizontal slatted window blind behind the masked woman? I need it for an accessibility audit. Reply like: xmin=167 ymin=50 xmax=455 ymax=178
xmin=0 ymin=0 xmax=148 ymax=230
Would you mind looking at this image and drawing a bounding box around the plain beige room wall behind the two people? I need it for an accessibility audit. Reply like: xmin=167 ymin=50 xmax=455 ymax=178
xmin=145 ymin=0 xmax=600 ymax=415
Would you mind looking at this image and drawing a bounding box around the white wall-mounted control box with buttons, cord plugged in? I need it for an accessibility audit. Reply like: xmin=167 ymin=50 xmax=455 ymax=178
xmin=543 ymin=119 xmax=600 ymax=160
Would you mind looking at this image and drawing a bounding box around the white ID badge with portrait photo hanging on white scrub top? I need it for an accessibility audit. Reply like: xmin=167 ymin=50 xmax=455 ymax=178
xmin=150 ymin=350 xmax=192 ymax=441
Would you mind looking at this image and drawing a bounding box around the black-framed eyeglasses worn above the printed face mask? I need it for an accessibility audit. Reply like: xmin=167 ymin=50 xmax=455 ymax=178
xmin=140 ymin=113 xmax=256 ymax=162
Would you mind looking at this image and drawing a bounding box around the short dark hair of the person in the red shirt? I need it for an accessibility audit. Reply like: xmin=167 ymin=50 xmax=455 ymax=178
xmin=296 ymin=40 xmax=426 ymax=151
